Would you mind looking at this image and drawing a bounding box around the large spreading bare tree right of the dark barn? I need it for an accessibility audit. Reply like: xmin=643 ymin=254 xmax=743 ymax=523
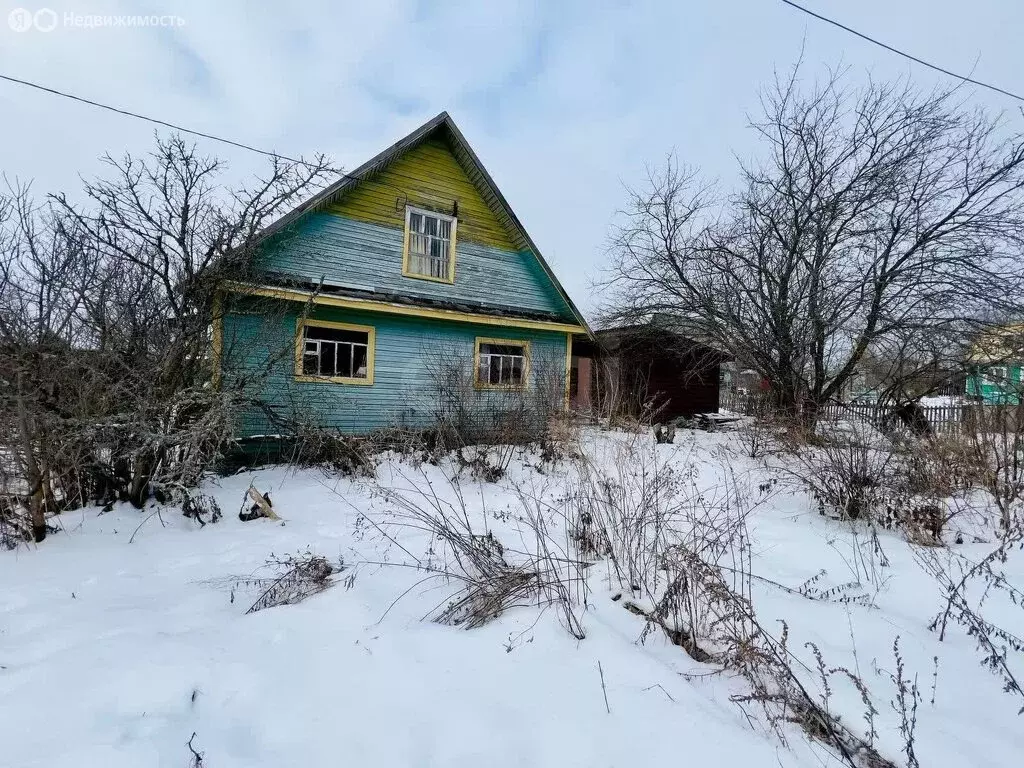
xmin=608 ymin=67 xmax=1024 ymax=422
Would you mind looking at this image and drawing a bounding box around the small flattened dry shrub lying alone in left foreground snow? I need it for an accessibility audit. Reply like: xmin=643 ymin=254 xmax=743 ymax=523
xmin=231 ymin=550 xmax=345 ymax=614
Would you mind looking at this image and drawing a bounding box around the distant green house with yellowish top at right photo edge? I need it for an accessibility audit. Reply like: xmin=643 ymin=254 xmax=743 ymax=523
xmin=965 ymin=324 xmax=1024 ymax=404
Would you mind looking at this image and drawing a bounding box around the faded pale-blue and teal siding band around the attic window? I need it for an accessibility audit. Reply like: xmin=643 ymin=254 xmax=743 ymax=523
xmin=258 ymin=210 xmax=574 ymax=319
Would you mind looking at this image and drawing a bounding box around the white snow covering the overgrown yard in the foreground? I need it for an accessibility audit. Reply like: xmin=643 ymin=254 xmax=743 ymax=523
xmin=0 ymin=431 xmax=1024 ymax=768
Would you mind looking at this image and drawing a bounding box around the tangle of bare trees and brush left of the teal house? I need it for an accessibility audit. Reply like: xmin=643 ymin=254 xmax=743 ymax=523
xmin=0 ymin=136 xmax=332 ymax=540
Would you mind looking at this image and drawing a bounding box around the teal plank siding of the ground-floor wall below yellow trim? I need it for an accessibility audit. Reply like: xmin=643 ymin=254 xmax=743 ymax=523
xmin=223 ymin=300 xmax=567 ymax=437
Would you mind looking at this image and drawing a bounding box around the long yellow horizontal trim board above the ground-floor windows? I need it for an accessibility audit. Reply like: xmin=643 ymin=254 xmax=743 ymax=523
xmin=223 ymin=281 xmax=588 ymax=334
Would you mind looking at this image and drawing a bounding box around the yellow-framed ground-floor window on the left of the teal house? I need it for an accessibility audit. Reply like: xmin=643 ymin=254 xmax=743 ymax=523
xmin=295 ymin=319 xmax=377 ymax=385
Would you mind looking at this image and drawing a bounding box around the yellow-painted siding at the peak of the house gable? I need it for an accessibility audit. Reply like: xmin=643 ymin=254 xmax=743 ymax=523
xmin=329 ymin=137 xmax=516 ymax=252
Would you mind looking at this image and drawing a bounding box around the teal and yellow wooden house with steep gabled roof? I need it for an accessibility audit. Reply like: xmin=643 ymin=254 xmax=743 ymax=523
xmin=214 ymin=113 xmax=590 ymax=437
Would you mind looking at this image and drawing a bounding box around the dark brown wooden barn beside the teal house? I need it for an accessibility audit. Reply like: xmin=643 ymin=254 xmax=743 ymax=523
xmin=570 ymin=323 xmax=729 ymax=422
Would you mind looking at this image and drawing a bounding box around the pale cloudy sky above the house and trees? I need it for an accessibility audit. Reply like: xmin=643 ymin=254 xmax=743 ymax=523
xmin=0 ymin=0 xmax=1024 ymax=319
